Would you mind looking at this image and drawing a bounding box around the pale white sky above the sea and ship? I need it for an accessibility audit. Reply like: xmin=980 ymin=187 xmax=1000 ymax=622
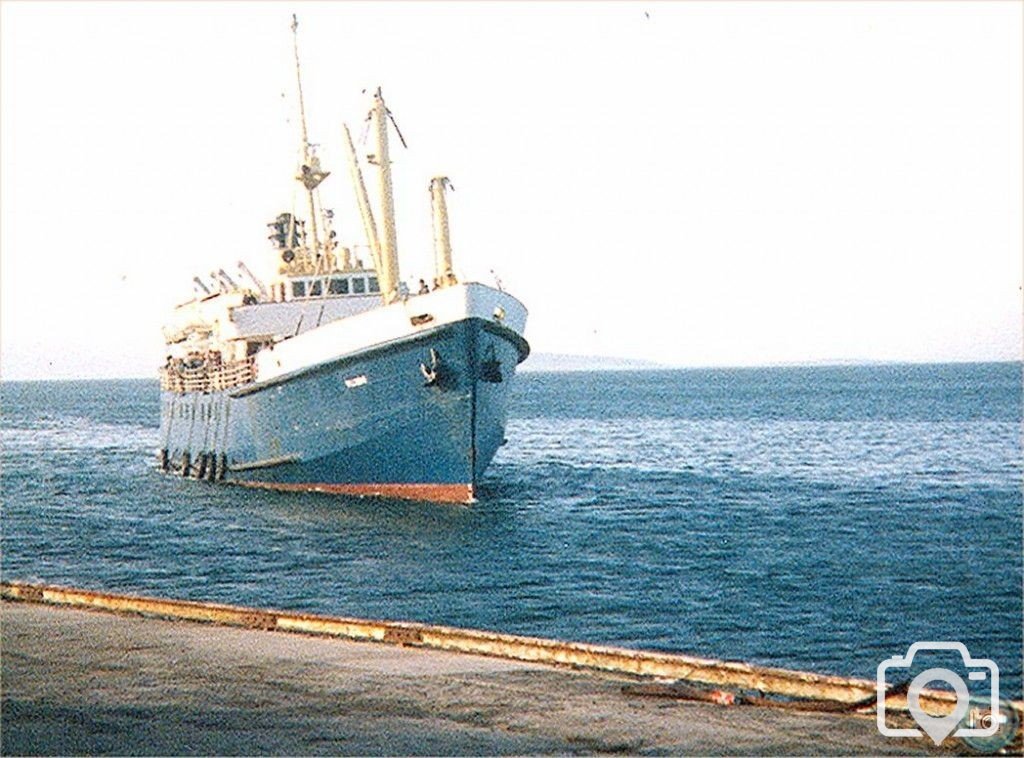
xmin=0 ymin=0 xmax=1024 ymax=379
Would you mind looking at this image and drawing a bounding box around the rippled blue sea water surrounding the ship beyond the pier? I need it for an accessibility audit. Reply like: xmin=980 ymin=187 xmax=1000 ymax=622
xmin=0 ymin=364 xmax=1022 ymax=697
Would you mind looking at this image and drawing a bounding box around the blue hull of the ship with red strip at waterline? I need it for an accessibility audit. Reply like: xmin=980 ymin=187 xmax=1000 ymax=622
xmin=161 ymin=319 xmax=528 ymax=502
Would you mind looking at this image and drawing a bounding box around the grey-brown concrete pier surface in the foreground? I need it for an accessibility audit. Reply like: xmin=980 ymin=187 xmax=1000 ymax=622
xmin=0 ymin=601 xmax=938 ymax=755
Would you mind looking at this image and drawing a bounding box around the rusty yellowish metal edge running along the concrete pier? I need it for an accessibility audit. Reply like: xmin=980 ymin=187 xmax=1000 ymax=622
xmin=0 ymin=582 xmax=1024 ymax=725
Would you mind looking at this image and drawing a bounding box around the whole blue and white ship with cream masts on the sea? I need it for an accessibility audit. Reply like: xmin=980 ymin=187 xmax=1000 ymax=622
xmin=159 ymin=17 xmax=529 ymax=503
